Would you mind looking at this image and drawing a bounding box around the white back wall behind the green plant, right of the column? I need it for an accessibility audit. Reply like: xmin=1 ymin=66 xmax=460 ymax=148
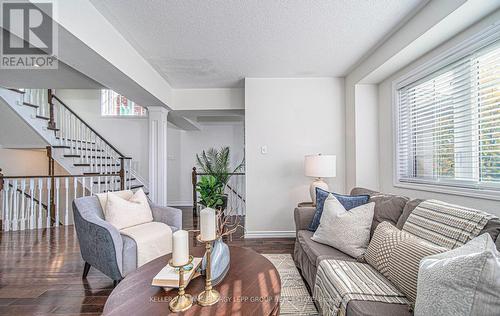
xmin=167 ymin=120 xmax=244 ymax=206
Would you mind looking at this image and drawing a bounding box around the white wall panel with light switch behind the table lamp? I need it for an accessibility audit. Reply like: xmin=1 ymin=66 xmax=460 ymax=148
xmin=245 ymin=78 xmax=345 ymax=237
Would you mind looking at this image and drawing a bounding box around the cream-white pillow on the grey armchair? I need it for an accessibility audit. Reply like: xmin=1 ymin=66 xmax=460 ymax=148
xmin=104 ymin=189 xmax=153 ymax=230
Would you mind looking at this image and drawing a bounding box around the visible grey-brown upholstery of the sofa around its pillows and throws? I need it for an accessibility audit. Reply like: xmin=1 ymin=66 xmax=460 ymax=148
xmin=293 ymin=188 xmax=500 ymax=316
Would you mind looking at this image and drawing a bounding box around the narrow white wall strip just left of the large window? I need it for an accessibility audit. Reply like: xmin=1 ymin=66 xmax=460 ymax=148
xmin=355 ymin=84 xmax=379 ymax=190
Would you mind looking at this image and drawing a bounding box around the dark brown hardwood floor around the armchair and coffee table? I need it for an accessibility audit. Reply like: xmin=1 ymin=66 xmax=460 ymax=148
xmin=0 ymin=209 xmax=294 ymax=315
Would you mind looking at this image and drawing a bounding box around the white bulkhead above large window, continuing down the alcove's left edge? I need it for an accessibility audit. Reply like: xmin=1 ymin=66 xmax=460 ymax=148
xmin=345 ymin=0 xmax=492 ymax=188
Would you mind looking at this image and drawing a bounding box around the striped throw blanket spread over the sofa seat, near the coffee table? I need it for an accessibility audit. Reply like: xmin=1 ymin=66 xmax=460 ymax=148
xmin=313 ymin=259 xmax=410 ymax=316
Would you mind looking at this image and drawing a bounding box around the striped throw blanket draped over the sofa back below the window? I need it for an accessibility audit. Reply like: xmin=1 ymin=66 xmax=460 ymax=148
xmin=403 ymin=200 xmax=494 ymax=249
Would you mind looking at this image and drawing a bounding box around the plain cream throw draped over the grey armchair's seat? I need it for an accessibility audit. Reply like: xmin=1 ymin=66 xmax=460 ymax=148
xmin=120 ymin=222 xmax=172 ymax=268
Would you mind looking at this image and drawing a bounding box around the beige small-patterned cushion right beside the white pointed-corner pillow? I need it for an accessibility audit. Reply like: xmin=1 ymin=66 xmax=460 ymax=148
xmin=364 ymin=222 xmax=412 ymax=277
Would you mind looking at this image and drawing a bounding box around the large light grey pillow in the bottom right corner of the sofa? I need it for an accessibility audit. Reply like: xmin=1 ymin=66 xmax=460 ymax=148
xmin=415 ymin=234 xmax=500 ymax=316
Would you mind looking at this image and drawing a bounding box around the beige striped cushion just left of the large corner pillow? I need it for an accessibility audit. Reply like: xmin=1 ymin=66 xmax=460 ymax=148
xmin=387 ymin=237 xmax=449 ymax=302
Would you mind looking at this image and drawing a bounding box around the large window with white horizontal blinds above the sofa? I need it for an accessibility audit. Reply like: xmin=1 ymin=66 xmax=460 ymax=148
xmin=396 ymin=34 xmax=500 ymax=194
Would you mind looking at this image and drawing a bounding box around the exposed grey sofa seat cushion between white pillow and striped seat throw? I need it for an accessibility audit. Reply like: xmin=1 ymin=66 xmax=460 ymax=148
xmin=297 ymin=230 xmax=356 ymax=266
